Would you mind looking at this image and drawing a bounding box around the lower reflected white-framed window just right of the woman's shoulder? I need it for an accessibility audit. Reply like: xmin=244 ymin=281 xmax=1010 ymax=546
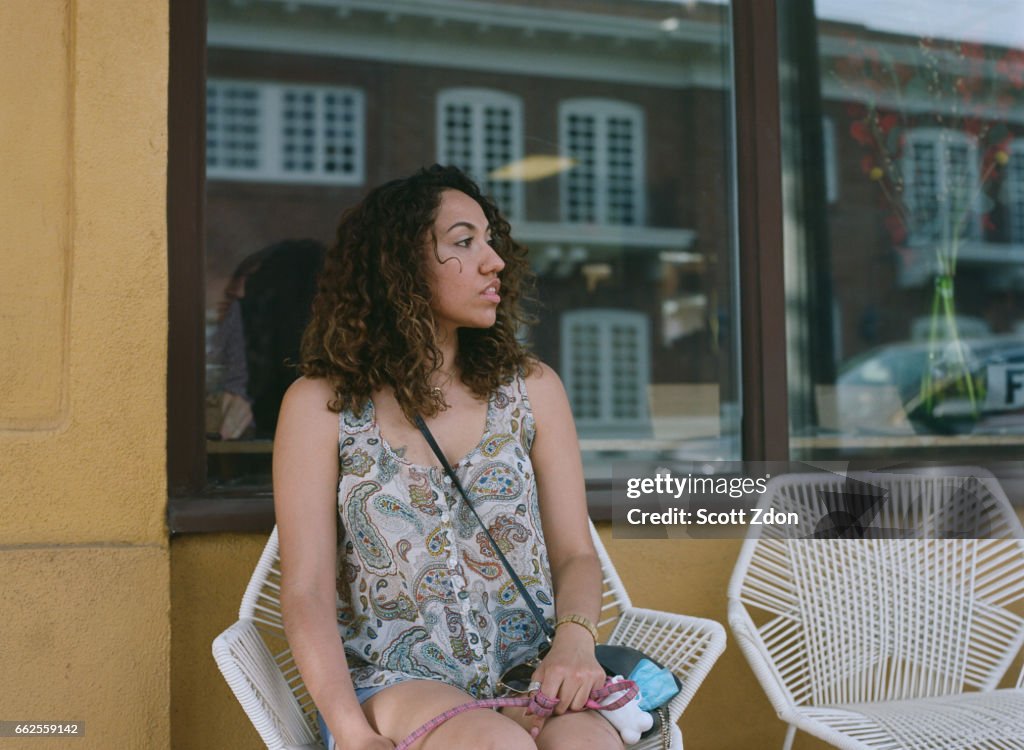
xmin=560 ymin=308 xmax=650 ymax=436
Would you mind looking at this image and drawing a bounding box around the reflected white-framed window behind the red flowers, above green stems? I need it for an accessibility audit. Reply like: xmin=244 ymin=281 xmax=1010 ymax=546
xmin=903 ymin=128 xmax=981 ymax=244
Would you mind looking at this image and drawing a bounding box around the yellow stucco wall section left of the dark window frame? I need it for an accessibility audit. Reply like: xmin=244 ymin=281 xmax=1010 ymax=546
xmin=0 ymin=0 xmax=170 ymax=750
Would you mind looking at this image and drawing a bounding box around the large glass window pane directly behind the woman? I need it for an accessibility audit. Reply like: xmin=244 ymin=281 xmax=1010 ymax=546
xmin=199 ymin=0 xmax=740 ymax=487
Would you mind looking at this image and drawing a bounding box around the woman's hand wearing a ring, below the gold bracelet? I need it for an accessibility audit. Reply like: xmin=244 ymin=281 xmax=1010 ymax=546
xmin=534 ymin=625 xmax=605 ymax=736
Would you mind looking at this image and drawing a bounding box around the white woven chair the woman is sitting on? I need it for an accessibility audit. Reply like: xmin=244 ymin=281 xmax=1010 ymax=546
xmin=213 ymin=525 xmax=725 ymax=750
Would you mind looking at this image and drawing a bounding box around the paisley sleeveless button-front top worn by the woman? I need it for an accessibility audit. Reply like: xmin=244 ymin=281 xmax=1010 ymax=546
xmin=337 ymin=377 xmax=554 ymax=698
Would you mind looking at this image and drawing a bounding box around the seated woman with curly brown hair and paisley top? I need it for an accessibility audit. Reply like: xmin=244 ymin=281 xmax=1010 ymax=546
xmin=273 ymin=166 xmax=622 ymax=750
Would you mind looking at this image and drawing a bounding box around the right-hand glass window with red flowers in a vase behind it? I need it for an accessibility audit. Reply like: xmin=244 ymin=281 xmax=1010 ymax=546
xmin=779 ymin=0 xmax=1024 ymax=459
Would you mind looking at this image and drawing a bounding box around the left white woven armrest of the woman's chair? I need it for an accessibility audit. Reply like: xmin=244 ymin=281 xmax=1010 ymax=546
xmin=213 ymin=619 xmax=323 ymax=750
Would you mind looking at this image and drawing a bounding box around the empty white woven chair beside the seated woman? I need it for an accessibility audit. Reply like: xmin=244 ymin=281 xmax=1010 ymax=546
xmin=729 ymin=469 xmax=1024 ymax=750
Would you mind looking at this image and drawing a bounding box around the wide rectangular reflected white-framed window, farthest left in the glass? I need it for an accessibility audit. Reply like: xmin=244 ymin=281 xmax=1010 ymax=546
xmin=206 ymin=79 xmax=366 ymax=185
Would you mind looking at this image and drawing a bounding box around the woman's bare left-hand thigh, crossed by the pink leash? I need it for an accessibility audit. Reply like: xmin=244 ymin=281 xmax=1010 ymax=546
xmin=362 ymin=679 xmax=537 ymax=750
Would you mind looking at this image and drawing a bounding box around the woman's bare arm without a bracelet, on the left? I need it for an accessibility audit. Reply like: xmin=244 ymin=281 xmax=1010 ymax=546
xmin=273 ymin=378 xmax=394 ymax=749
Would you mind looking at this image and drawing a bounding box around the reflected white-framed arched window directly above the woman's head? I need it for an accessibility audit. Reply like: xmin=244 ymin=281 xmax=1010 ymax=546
xmin=437 ymin=88 xmax=524 ymax=219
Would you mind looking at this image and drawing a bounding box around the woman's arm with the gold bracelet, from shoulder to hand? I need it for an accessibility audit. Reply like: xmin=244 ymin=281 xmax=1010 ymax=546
xmin=526 ymin=365 xmax=605 ymax=713
